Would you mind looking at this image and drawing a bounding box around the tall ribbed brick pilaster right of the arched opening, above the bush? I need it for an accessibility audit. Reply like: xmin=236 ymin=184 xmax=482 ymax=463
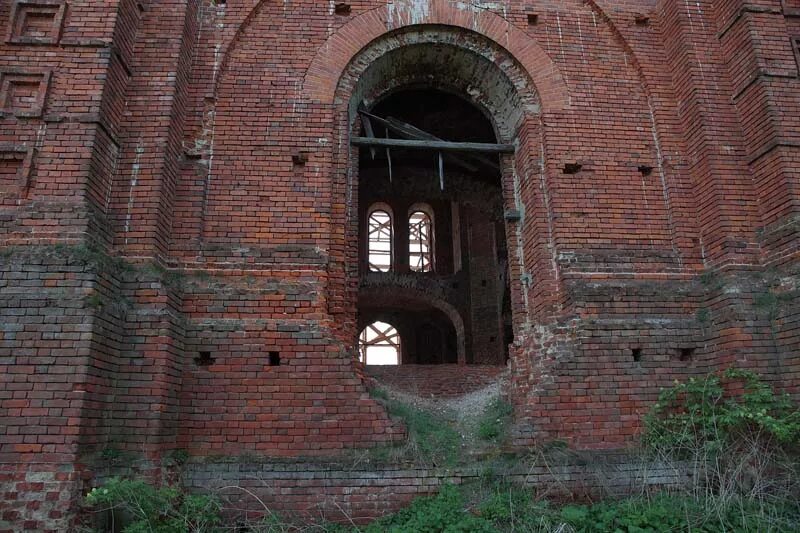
xmin=658 ymin=1 xmax=759 ymax=267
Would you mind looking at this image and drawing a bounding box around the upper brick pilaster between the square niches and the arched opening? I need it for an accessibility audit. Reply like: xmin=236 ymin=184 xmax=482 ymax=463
xmin=113 ymin=0 xmax=199 ymax=257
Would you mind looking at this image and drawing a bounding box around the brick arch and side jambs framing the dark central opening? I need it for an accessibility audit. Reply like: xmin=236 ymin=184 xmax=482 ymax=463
xmin=320 ymin=17 xmax=569 ymax=374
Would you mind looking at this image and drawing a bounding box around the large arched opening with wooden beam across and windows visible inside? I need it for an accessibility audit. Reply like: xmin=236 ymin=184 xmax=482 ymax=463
xmin=335 ymin=25 xmax=541 ymax=386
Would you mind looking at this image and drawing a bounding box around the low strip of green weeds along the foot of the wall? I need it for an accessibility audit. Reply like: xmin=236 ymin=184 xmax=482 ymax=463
xmin=87 ymin=480 xmax=800 ymax=533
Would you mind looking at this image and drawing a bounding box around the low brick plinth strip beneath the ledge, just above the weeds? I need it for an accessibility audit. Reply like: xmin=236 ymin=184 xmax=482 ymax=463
xmin=184 ymin=452 xmax=682 ymax=524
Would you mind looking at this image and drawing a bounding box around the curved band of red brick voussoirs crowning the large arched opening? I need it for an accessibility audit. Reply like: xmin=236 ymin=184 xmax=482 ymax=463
xmin=303 ymin=0 xmax=569 ymax=112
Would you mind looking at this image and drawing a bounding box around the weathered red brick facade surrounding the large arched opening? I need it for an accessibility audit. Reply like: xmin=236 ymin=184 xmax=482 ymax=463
xmin=0 ymin=0 xmax=800 ymax=531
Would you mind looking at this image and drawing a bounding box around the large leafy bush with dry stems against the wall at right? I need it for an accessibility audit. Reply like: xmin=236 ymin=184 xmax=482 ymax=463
xmin=643 ymin=368 xmax=800 ymax=531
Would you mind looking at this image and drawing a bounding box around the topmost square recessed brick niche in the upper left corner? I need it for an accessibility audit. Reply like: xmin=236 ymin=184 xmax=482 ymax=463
xmin=6 ymin=0 xmax=67 ymax=44
